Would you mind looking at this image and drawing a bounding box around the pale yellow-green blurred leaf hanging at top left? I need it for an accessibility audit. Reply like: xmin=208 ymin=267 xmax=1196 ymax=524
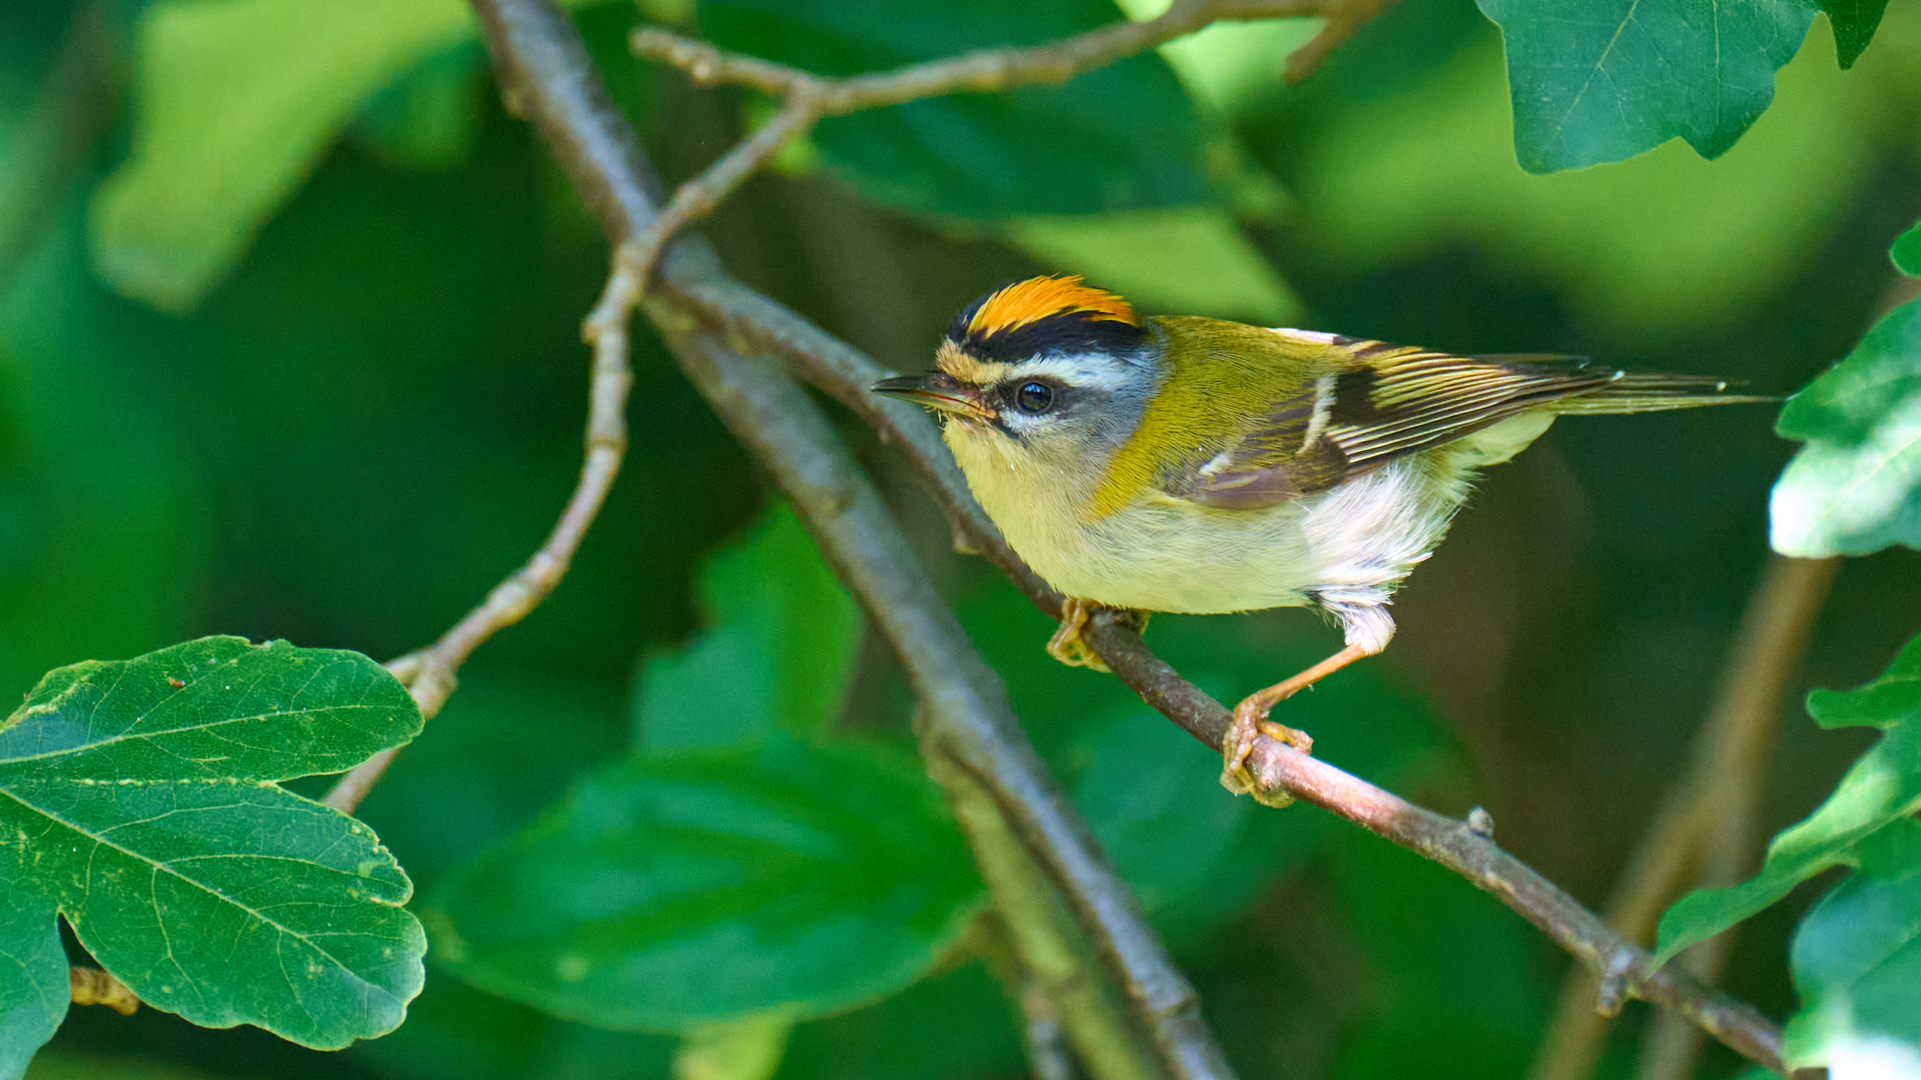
xmin=92 ymin=0 xmax=484 ymax=311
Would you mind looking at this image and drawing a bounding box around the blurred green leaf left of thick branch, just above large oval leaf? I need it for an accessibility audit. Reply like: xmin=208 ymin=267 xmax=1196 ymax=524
xmin=634 ymin=503 xmax=861 ymax=748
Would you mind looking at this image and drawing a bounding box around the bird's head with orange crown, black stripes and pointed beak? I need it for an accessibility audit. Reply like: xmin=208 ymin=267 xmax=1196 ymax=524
xmin=874 ymin=277 xmax=1160 ymax=465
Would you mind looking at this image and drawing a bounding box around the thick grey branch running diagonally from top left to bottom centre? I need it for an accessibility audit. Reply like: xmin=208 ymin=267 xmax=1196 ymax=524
xmin=473 ymin=0 xmax=1231 ymax=1080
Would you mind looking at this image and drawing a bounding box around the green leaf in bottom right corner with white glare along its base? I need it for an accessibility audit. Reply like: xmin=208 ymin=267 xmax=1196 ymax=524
xmin=1785 ymin=819 xmax=1921 ymax=1076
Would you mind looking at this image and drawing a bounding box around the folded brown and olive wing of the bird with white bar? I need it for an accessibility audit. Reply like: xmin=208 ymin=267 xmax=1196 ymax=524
xmin=1158 ymin=338 xmax=1621 ymax=509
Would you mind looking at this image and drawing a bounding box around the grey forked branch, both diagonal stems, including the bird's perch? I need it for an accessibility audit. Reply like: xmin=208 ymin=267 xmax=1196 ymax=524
xmin=473 ymin=0 xmax=1783 ymax=1076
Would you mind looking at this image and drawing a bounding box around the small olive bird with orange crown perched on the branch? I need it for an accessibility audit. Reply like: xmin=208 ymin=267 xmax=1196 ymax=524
xmin=874 ymin=277 xmax=1769 ymax=794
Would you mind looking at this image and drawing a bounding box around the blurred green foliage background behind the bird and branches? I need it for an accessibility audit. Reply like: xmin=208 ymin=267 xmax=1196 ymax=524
xmin=0 ymin=0 xmax=1921 ymax=1080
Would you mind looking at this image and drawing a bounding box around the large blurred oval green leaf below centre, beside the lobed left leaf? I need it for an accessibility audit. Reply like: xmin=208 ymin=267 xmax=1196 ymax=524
xmin=426 ymin=740 xmax=980 ymax=1032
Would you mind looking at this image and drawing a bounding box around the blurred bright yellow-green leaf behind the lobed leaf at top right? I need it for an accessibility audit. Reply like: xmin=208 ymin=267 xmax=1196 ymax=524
xmin=1287 ymin=26 xmax=1890 ymax=336
